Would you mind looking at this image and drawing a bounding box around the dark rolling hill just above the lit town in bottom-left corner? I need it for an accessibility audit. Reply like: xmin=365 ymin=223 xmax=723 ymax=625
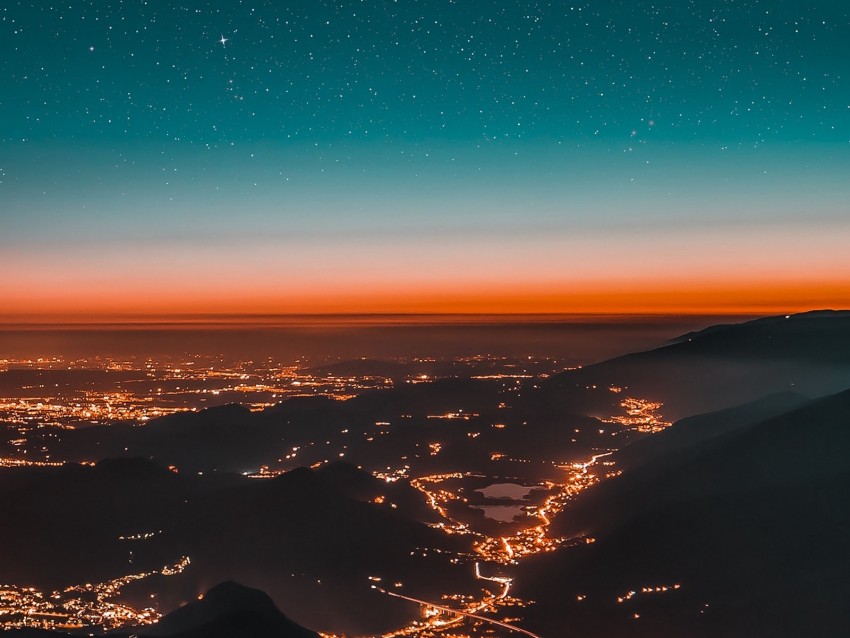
xmin=0 ymin=459 xmax=477 ymax=634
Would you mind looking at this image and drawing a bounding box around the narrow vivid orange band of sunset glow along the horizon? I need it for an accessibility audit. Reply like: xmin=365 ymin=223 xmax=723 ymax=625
xmin=0 ymin=280 xmax=850 ymax=324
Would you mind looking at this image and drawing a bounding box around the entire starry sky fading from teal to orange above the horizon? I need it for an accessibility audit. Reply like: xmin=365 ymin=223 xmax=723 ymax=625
xmin=0 ymin=0 xmax=850 ymax=318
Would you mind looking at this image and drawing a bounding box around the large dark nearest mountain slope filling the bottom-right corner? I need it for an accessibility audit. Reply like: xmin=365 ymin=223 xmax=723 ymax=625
xmin=519 ymin=391 xmax=850 ymax=638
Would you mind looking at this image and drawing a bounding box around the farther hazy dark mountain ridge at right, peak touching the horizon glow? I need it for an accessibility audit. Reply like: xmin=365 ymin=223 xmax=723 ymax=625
xmin=535 ymin=311 xmax=850 ymax=419
